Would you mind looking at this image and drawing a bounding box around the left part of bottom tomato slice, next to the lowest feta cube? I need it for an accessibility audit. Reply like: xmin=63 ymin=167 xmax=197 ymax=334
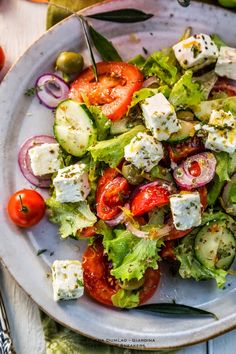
xmin=82 ymin=240 xmax=120 ymax=305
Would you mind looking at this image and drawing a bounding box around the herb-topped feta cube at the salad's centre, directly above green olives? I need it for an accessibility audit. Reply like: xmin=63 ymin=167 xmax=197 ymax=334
xmin=125 ymin=133 xmax=164 ymax=172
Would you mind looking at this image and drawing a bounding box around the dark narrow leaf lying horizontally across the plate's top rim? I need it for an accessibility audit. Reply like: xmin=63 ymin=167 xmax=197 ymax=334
xmin=87 ymin=9 xmax=153 ymax=23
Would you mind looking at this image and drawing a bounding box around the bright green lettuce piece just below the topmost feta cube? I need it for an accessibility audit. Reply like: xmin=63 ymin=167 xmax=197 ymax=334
xmin=169 ymin=70 xmax=204 ymax=108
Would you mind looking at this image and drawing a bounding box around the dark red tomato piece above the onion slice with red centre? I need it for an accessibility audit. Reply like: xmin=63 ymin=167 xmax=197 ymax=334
xmin=168 ymin=136 xmax=205 ymax=163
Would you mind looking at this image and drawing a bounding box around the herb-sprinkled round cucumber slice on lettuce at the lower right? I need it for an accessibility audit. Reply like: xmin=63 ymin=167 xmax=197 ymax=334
xmin=195 ymin=222 xmax=236 ymax=270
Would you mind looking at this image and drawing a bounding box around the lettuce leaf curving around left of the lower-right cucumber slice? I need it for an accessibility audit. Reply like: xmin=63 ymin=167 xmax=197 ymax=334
xmin=175 ymin=230 xmax=227 ymax=288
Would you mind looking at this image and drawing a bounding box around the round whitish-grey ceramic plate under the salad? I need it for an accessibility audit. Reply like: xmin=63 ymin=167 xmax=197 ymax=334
xmin=0 ymin=0 xmax=236 ymax=349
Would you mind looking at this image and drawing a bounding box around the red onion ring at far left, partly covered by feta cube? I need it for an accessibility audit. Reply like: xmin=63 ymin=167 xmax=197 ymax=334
xmin=18 ymin=135 xmax=56 ymax=188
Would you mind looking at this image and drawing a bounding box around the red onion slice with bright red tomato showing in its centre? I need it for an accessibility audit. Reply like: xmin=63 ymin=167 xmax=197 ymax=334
xmin=173 ymin=152 xmax=216 ymax=190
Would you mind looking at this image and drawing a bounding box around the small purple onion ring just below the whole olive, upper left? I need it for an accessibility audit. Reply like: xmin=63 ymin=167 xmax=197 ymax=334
xmin=35 ymin=73 xmax=69 ymax=109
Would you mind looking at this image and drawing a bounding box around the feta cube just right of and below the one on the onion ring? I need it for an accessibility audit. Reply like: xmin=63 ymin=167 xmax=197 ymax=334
xmin=53 ymin=163 xmax=90 ymax=203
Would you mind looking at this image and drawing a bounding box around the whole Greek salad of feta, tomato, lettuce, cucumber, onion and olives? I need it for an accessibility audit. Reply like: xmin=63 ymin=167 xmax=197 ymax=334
xmin=8 ymin=28 xmax=236 ymax=308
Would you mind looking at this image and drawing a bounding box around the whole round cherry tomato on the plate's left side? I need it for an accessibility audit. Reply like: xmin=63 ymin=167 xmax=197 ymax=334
xmin=7 ymin=189 xmax=46 ymax=227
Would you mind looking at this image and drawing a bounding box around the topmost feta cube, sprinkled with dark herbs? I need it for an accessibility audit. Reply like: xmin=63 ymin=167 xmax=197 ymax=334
xmin=173 ymin=33 xmax=219 ymax=71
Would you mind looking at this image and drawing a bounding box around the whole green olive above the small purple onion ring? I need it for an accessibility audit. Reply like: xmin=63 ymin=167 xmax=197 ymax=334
xmin=56 ymin=52 xmax=84 ymax=74
